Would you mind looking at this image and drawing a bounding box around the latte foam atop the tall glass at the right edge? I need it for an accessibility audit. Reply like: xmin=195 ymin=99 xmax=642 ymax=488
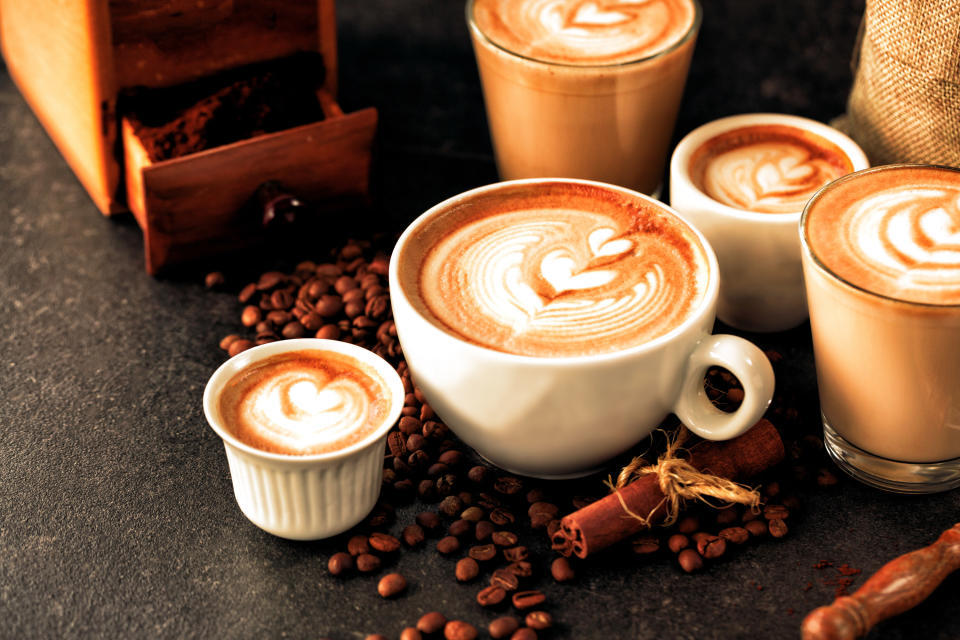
xmin=805 ymin=167 xmax=960 ymax=305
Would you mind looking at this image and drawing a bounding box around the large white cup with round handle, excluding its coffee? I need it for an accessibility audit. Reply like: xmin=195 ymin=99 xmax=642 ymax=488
xmin=390 ymin=179 xmax=774 ymax=478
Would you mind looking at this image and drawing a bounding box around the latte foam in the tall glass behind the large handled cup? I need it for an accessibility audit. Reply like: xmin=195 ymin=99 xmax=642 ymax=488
xmin=473 ymin=0 xmax=696 ymax=65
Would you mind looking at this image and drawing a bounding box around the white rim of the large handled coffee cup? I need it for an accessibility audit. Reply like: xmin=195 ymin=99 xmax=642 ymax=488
xmin=389 ymin=178 xmax=720 ymax=367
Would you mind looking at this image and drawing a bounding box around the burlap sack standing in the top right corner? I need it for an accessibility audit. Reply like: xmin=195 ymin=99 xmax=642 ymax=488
xmin=835 ymin=0 xmax=960 ymax=166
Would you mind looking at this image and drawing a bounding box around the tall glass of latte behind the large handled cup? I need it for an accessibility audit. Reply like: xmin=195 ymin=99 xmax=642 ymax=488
xmin=467 ymin=0 xmax=700 ymax=194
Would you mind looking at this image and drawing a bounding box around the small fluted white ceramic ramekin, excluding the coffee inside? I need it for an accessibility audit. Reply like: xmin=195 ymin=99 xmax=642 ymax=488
xmin=203 ymin=338 xmax=404 ymax=540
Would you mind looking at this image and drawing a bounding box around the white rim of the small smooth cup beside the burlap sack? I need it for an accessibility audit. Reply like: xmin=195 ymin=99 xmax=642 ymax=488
xmin=670 ymin=111 xmax=870 ymax=224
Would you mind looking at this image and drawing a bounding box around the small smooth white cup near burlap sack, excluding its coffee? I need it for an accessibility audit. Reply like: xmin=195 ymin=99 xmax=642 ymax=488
xmin=670 ymin=113 xmax=870 ymax=331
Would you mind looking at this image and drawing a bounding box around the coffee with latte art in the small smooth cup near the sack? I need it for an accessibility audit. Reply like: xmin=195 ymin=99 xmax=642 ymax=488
xmin=690 ymin=124 xmax=853 ymax=213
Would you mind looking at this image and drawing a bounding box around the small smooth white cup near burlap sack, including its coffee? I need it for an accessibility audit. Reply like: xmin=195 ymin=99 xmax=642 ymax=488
xmin=670 ymin=113 xmax=870 ymax=332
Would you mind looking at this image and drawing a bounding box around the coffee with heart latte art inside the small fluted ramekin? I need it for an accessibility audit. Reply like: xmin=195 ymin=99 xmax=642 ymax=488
xmin=219 ymin=350 xmax=389 ymax=455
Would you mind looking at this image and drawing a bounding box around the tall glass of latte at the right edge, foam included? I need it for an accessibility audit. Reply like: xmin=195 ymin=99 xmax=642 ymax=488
xmin=800 ymin=165 xmax=960 ymax=493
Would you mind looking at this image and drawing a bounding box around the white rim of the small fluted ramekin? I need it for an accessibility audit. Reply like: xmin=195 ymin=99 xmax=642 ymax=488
xmin=203 ymin=338 xmax=405 ymax=464
